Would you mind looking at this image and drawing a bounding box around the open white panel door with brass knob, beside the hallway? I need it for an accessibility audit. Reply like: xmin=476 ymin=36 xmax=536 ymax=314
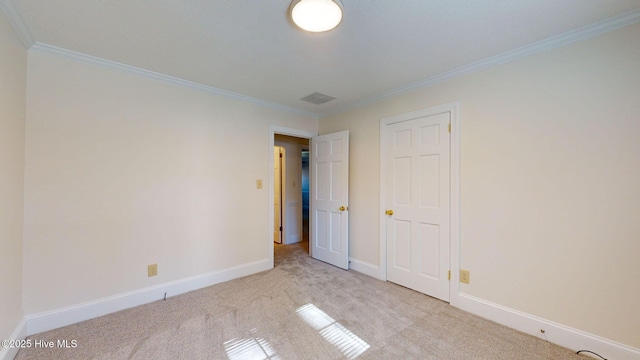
xmin=309 ymin=131 xmax=349 ymax=269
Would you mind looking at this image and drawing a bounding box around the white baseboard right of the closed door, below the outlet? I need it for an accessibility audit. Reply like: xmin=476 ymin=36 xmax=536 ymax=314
xmin=458 ymin=293 xmax=640 ymax=360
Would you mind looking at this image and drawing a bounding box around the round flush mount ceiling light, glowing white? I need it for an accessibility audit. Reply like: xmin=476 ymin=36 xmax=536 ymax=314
xmin=290 ymin=0 xmax=342 ymax=32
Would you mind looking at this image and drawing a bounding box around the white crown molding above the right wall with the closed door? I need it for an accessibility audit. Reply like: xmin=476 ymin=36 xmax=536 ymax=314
xmin=318 ymin=9 xmax=640 ymax=119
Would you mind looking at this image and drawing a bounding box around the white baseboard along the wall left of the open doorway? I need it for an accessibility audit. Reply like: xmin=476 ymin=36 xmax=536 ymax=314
xmin=25 ymin=259 xmax=271 ymax=335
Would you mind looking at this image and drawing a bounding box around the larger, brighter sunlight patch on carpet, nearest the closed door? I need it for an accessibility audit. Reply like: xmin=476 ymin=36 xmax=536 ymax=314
xmin=296 ymin=304 xmax=370 ymax=359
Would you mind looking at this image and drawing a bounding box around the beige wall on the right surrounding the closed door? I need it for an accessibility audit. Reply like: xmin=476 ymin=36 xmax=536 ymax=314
xmin=320 ymin=24 xmax=640 ymax=348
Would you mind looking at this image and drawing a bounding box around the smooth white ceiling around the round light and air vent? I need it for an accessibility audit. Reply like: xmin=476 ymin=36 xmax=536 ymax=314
xmin=0 ymin=0 xmax=640 ymax=116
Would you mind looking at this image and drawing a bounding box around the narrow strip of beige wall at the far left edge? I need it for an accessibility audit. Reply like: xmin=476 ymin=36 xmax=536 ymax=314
xmin=0 ymin=11 xmax=27 ymax=340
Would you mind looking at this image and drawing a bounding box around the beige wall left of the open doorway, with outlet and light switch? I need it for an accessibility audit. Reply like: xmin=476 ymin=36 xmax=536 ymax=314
xmin=24 ymin=52 xmax=317 ymax=314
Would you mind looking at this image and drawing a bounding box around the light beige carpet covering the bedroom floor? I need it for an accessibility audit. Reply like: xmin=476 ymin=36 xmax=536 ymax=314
xmin=16 ymin=243 xmax=590 ymax=360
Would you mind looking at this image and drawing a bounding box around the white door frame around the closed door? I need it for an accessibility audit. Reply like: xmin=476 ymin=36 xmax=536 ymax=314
xmin=378 ymin=102 xmax=460 ymax=307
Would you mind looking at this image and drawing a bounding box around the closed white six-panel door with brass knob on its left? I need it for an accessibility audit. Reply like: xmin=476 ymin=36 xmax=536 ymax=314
xmin=382 ymin=112 xmax=451 ymax=301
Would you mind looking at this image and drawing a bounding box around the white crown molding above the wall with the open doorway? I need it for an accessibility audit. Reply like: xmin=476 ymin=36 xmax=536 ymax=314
xmin=30 ymin=42 xmax=318 ymax=119
